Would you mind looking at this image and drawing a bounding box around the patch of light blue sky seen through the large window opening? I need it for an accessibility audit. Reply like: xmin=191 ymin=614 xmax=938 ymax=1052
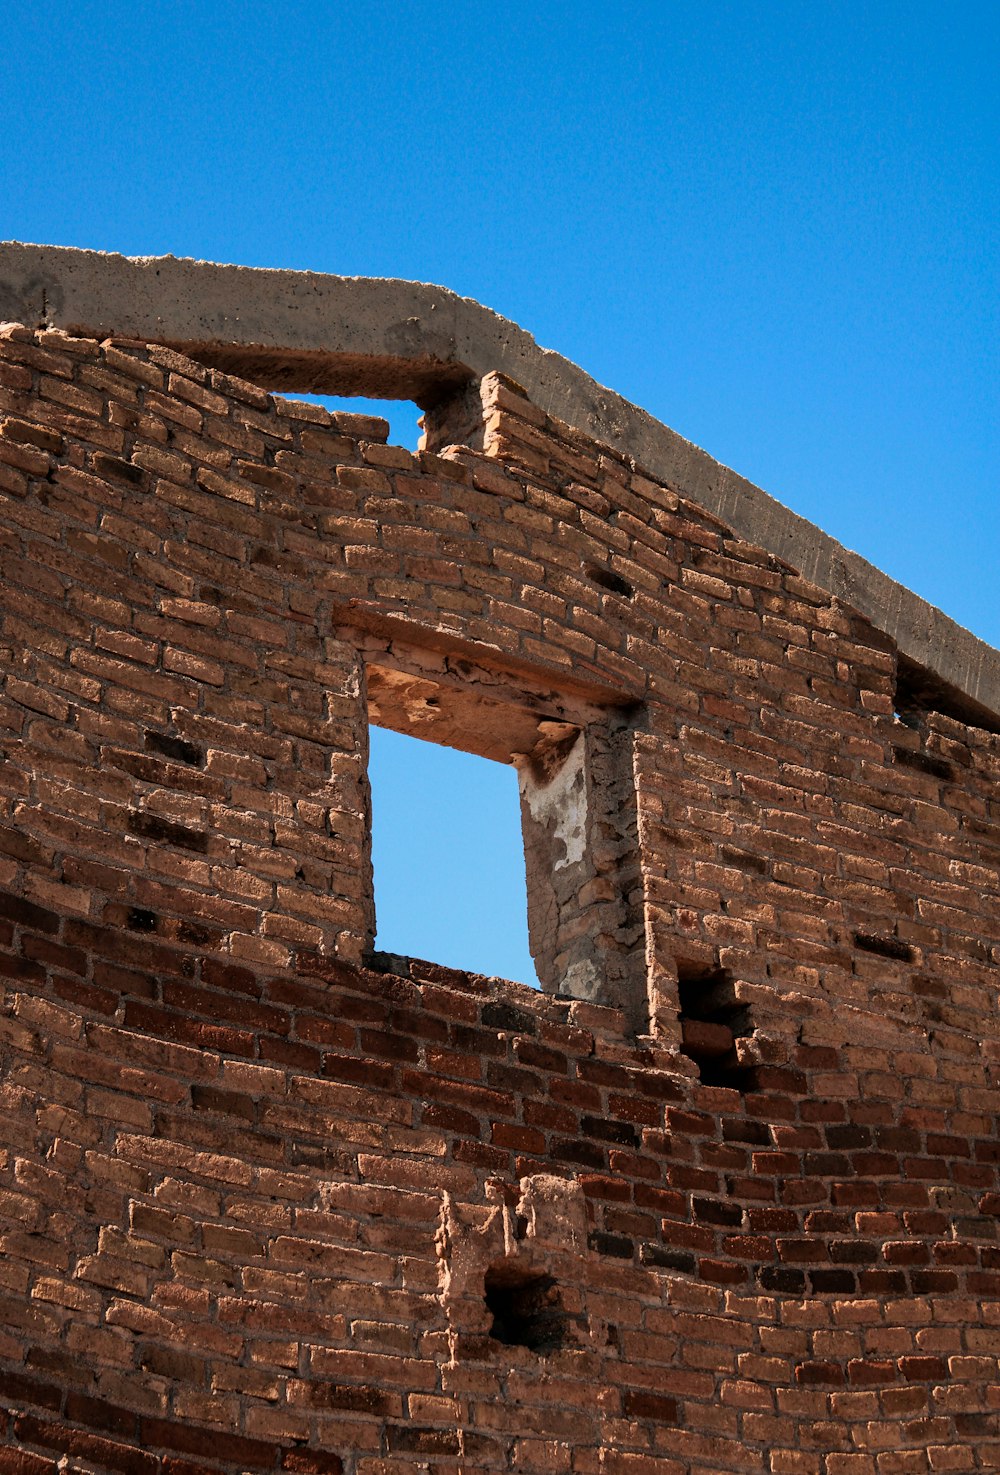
xmin=369 ymin=727 xmax=538 ymax=988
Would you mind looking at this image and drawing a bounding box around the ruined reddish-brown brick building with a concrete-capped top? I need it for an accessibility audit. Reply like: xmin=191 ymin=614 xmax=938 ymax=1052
xmin=0 ymin=245 xmax=1000 ymax=1475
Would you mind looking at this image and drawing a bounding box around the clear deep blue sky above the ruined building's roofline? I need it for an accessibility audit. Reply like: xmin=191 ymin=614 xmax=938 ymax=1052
xmin=0 ymin=0 xmax=1000 ymax=974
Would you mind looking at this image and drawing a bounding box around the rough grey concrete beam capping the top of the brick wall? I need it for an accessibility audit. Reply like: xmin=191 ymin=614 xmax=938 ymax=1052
xmin=0 ymin=242 xmax=1000 ymax=726
